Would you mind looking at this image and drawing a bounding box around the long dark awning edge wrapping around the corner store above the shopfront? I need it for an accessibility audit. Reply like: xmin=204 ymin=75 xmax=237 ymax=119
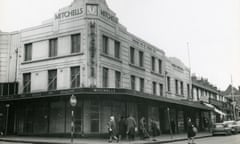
xmin=0 ymin=88 xmax=212 ymax=111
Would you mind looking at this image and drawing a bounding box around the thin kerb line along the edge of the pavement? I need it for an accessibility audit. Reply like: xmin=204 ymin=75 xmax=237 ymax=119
xmin=0 ymin=135 xmax=212 ymax=144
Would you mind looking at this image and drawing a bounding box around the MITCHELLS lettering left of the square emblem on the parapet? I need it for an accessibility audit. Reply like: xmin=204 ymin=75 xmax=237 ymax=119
xmin=55 ymin=8 xmax=84 ymax=20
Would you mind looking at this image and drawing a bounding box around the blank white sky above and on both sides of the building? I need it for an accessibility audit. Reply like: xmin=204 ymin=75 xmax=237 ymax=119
xmin=0 ymin=0 xmax=240 ymax=90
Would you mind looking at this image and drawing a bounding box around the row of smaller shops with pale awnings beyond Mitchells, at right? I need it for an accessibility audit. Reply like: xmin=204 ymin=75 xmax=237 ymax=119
xmin=192 ymin=76 xmax=233 ymax=123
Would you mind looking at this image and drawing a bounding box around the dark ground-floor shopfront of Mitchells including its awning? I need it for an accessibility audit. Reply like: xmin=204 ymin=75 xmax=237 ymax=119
xmin=0 ymin=89 xmax=210 ymax=136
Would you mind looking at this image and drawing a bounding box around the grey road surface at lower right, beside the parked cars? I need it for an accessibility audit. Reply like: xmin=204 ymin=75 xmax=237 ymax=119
xmin=166 ymin=134 xmax=240 ymax=144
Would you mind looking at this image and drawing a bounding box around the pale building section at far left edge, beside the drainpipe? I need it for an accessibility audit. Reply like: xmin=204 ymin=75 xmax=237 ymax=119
xmin=0 ymin=31 xmax=20 ymax=96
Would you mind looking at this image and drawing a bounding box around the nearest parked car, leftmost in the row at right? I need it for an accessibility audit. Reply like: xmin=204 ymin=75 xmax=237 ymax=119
xmin=212 ymin=123 xmax=232 ymax=135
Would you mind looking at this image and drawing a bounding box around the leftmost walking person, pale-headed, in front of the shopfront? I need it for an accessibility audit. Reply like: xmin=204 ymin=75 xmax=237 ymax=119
xmin=107 ymin=116 xmax=119 ymax=143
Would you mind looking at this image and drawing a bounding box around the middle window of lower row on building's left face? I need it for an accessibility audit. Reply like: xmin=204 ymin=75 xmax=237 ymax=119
xmin=48 ymin=70 xmax=57 ymax=90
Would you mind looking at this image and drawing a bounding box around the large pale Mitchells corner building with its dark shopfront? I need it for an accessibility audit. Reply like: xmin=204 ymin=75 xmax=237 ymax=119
xmin=0 ymin=0 xmax=211 ymax=136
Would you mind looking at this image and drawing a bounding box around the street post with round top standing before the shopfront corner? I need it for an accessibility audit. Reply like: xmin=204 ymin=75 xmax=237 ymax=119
xmin=70 ymin=95 xmax=77 ymax=144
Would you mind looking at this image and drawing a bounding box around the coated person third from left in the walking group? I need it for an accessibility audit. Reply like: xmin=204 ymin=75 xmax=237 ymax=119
xmin=126 ymin=115 xmax=137 ymax=140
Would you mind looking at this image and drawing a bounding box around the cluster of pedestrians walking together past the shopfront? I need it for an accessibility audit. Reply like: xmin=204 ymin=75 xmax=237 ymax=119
xmin=107 ymin=115 xmax=160 ymax=143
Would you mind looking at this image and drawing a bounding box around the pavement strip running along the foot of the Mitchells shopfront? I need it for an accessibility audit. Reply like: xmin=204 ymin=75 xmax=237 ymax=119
xmin=0 ymin=132 xmax=212 ymax=144
